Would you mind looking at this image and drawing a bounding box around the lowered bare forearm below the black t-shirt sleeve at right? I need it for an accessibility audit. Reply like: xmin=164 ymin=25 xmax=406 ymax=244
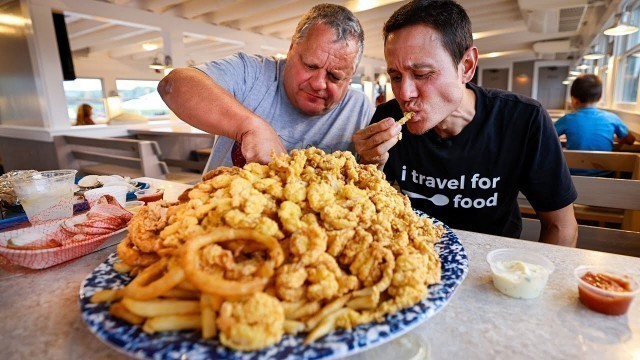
xmin=536 ymin=204 xmax=578 ymax=247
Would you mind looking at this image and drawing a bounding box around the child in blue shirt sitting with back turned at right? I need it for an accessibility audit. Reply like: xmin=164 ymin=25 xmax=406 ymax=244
xmin=554 ymin=74 xmax=636 ymax=176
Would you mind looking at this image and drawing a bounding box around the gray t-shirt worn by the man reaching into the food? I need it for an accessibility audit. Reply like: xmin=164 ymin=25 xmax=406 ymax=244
xmin=196 ymin=53 xmax=374 ymax=173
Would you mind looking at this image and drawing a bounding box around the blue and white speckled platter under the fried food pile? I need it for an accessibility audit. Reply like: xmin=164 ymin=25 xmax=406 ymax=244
xmin=80 ymin=211 xmax=468 ymax=359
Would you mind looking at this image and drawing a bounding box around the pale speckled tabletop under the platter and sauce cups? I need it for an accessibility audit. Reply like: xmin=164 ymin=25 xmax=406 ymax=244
xmin=0 ymin=179 xmax=640 ymax=359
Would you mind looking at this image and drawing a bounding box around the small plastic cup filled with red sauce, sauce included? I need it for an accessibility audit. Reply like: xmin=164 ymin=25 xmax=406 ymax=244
xmin=573 ymin=265 xmax=640 ymax=315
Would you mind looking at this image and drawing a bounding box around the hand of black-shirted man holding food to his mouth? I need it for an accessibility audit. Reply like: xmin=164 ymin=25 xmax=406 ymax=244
xmin=352 ymin=118 xmax=402 ymax=170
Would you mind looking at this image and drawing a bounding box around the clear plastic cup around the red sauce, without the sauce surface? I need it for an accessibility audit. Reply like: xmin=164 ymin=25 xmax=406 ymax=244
xmin=573 ymin=265 xmax=640 ymax=315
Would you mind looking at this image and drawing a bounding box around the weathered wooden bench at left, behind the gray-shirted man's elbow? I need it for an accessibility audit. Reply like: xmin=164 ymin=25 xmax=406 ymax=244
xmin=54 ymin=135 xmax=201 ymax=184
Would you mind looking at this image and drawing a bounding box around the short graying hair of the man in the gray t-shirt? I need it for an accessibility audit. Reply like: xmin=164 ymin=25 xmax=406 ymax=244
xmin=291 ymin=4 xmax=364 ymax=66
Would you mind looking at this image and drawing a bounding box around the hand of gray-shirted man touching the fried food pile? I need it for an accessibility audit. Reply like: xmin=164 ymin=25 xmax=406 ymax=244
xmin=239 ymin=121 xmax=287 ymax=164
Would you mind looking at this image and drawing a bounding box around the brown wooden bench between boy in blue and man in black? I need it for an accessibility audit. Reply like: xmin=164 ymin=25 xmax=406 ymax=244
xmin=518 ymin=150 xmax=640 ymax=231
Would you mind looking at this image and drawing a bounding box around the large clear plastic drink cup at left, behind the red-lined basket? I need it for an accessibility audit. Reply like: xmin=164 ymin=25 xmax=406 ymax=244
xmin=11 ymin=170 xmax=77 ymax=224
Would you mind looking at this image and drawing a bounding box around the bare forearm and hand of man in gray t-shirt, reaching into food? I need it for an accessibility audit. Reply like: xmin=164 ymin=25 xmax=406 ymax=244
xmin=158 ymin=68 xmax=286 ymax=163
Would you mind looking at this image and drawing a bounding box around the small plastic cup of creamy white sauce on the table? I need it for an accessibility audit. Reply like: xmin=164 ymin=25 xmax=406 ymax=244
xmin=487 ymin=249 xmax=555 ymax=299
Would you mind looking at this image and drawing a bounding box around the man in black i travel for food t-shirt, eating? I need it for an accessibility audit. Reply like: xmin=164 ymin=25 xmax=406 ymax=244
xmin=353 ymin=0 xmax=578 ymax=246
